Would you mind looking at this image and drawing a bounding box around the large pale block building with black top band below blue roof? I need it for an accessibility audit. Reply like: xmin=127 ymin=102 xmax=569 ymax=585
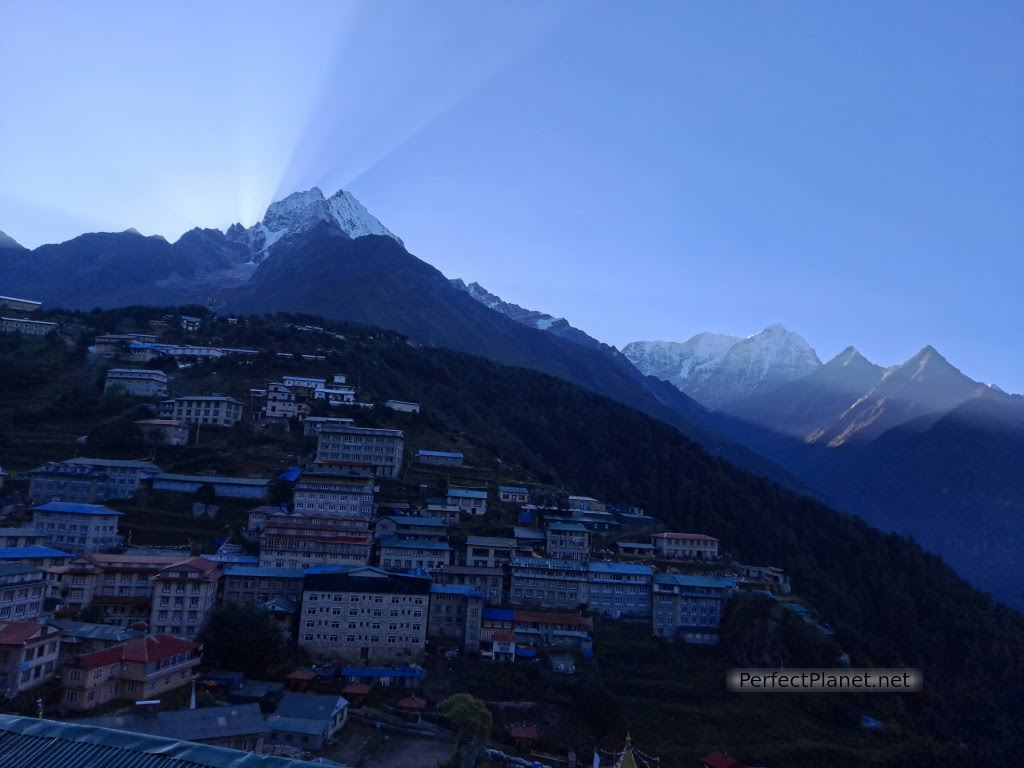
xmin=299 ymin=566 xmax=430 ymax=663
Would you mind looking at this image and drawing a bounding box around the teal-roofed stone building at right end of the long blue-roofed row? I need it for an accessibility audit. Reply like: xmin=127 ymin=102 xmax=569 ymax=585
xmin=651 ymin=573 xmax=736 ymax=644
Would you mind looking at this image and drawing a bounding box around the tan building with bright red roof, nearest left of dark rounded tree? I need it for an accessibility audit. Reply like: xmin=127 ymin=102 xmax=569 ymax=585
xmin=60 ymin=635 xmax=200 ymax=712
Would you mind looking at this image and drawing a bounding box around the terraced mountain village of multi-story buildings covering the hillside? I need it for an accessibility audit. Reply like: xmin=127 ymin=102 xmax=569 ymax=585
xmin=0 ymin=298 xmax=815 ymax=768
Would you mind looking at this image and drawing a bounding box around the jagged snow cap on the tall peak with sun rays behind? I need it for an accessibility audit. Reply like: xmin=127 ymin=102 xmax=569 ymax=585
xmin=226 ymin=186 xmax=404 ymax=261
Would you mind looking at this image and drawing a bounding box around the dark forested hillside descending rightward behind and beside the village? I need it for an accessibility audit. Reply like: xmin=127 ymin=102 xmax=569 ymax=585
xmin=0 ymin=308 xmax=1024 ymax=765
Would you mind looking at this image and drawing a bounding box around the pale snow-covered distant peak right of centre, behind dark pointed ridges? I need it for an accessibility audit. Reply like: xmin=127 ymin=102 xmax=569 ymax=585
xmin=623 ymin=325 xmax=821 ymax=410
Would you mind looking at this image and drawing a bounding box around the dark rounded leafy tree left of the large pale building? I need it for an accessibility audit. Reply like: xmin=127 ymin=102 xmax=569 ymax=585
xmin=199 ymin=603 xmax=288 ymax=677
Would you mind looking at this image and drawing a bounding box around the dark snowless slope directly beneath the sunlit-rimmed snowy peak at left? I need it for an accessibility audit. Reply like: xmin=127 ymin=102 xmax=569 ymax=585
xmin=222 ymin=225 xmax=800 ymax=487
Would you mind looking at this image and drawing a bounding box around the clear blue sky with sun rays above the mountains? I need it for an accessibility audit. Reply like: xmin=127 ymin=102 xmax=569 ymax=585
xmin=0 ymin=0 xmax=1024 ymax=391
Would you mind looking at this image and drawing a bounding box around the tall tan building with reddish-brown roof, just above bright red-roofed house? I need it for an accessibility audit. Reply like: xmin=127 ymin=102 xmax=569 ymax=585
xmin=150 ymin=557 xmax=223 ymax=638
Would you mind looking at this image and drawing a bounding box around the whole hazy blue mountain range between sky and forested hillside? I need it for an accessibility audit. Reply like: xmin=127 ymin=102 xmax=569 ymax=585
xmin=0 ymin=188 xmax=1024 ymax=607
